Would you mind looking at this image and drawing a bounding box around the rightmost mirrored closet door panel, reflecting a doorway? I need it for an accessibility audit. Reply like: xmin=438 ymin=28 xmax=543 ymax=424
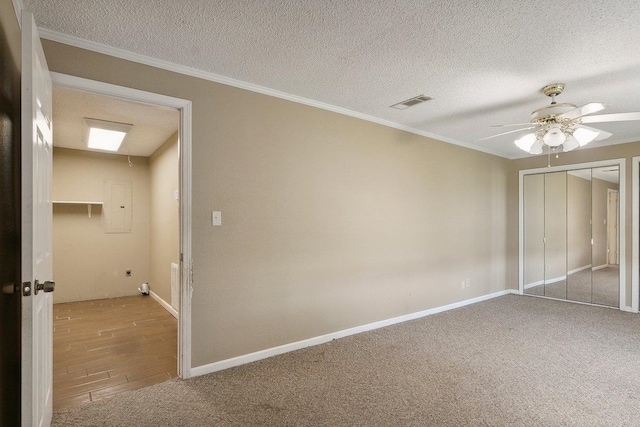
xmin=591 ymin=166 xmax=620 ymax=307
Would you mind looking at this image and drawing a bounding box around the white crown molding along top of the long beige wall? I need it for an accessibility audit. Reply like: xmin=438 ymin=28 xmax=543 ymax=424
xmin=38 ymin=28 xmax=509 ymax=158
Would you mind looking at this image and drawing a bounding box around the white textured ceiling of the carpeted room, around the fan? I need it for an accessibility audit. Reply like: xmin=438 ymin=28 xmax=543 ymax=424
xmin=24 ymin=0 xmax=640 ymax=158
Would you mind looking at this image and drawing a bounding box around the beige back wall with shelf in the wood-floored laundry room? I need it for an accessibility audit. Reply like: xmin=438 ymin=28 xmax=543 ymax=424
xmin=53 ymin=148 xmax=150 ymax=303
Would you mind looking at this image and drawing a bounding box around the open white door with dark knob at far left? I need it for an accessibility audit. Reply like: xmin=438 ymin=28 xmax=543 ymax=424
xmin=22 ymin=11 xmax=54 ymax=427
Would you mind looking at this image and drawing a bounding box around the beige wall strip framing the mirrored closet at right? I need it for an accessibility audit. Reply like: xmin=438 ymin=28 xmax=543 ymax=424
xmin=508 ymin=142 xmax=640 ymax=306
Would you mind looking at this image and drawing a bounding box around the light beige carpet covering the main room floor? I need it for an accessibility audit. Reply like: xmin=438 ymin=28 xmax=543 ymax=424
xmin=53 ymin=295 xmax=640 ymax=426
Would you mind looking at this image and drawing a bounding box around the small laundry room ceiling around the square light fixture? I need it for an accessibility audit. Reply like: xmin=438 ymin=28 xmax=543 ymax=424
xmin=53 ymin=87 xmax=180 ymax=157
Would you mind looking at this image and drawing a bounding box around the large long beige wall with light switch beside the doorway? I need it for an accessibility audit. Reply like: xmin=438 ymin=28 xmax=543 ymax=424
xmin=43 ymin=41 xmax=510 ymax=366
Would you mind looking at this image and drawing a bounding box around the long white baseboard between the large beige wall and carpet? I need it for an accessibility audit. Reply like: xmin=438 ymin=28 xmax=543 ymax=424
xmin=191 ymin=289 xmax=518 ymax=377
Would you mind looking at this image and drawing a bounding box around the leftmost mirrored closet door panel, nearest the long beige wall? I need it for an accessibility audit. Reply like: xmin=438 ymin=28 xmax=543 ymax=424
xmin=523 ymin=174 xmax=544 ymax=295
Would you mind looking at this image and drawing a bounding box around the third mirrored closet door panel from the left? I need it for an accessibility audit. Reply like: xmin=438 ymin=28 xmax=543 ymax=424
xmin=567 ymin=169 xmax=591 ymax=302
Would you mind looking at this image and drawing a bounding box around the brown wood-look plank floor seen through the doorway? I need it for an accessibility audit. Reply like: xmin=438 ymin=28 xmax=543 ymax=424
xmin=53 ymin=295 xmax=178 ymax=412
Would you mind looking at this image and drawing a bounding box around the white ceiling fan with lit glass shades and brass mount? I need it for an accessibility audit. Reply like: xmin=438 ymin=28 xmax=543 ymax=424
xmin=476 ymin=83 xmax=640 ymax=154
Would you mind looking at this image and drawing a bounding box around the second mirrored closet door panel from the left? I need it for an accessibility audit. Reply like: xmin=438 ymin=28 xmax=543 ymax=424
xmin=544 ymin=171 xmax=567 ymax=299
